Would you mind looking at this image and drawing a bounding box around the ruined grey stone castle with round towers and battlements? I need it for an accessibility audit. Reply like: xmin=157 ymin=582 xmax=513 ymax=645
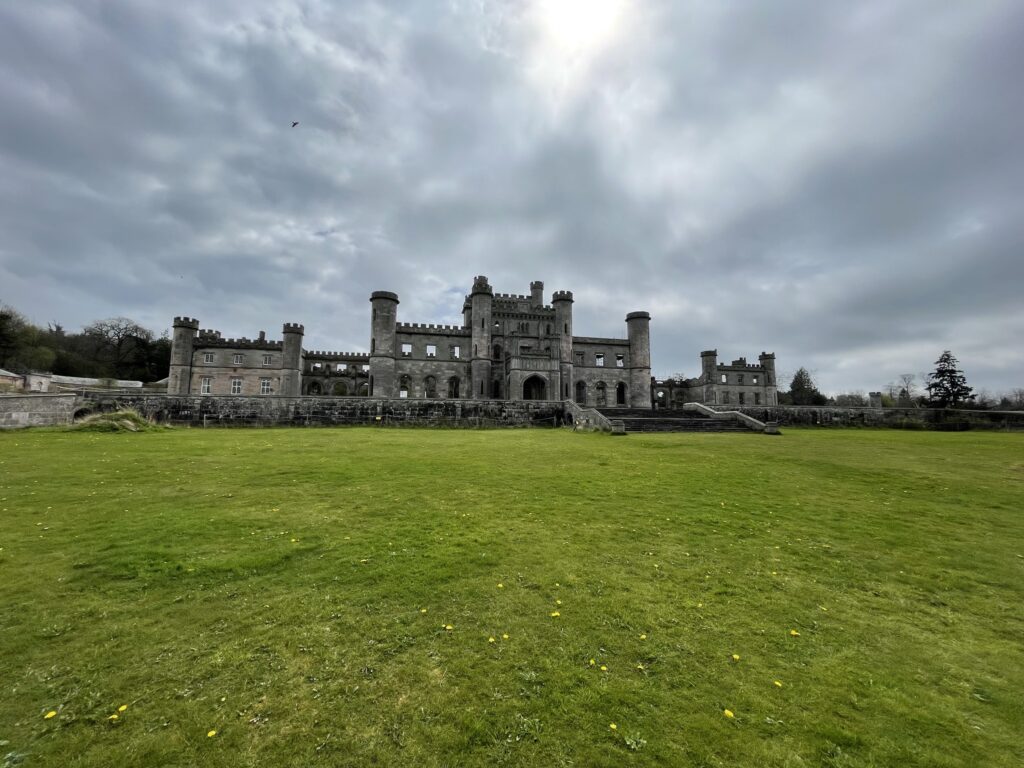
xmin=167 ymin=276 xmax=776 ymax=408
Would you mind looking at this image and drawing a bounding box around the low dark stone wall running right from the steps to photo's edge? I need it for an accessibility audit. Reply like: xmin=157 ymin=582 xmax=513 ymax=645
xmin=711 ymin=406 xmax=1024 ymax=430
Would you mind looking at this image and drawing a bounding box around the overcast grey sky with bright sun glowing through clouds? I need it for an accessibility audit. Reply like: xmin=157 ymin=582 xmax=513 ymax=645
xmin=0 ymin=0 xmax=1024 ymax=392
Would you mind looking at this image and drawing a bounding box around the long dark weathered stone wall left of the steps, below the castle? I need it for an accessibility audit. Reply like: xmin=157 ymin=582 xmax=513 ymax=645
xmin=82 ymin=394 xmax=564 ymax=427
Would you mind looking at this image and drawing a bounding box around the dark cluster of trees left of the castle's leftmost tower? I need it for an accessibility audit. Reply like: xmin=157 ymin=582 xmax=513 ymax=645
xmin=0 ymin=304 xmax=171 ymax=382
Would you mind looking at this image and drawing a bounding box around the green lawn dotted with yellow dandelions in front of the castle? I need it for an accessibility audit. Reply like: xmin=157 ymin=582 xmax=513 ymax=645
xmin=0 ymin=429 xmax=1024 ymax=767
